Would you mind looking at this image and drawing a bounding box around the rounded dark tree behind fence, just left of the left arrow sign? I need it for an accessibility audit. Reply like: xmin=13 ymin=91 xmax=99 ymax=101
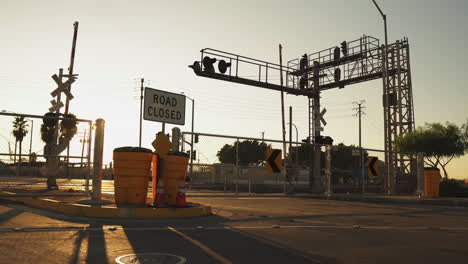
xmin=216 ymin=140 xmax=271 ymax=166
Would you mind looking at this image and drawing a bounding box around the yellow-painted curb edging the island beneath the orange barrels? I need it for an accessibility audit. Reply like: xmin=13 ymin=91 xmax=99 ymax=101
xmin=0 ymin=193 xmax=211 ymax=219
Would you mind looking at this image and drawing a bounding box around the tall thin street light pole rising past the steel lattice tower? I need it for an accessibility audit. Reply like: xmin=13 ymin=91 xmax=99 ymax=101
xmin=372 ymin=0 xmax=393 ymax=194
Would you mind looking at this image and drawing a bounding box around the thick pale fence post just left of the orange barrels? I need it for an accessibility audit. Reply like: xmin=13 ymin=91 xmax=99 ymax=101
xmin=91 ymin=118 xmax=105 ymax=200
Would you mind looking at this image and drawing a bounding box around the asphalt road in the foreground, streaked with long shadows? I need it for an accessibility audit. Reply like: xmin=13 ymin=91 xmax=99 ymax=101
xmin=0 ymin=193 xmax=468 ymax=264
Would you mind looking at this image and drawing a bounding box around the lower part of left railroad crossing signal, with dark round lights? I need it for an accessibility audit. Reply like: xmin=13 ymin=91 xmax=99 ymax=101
xmin=41 ymin=113 xmax=77 ymax=189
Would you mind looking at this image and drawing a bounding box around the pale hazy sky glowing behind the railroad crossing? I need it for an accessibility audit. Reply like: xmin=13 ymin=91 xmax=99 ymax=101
xmin=0 ymin=0 xmax=468 ymax=177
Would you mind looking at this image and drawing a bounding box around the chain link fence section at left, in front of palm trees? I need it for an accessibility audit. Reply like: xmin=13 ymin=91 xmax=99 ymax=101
xmin=0 ymin=112 xmax=93 ymax=195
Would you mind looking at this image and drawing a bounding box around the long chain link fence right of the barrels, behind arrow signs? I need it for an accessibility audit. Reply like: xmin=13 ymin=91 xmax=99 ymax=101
xmin=182 ymin=132 xmax=424 ymax=195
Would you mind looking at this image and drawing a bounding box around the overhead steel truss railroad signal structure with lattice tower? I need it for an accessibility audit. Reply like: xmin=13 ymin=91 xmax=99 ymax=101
xmin=189 ymin=36 xmax=416 ymax=193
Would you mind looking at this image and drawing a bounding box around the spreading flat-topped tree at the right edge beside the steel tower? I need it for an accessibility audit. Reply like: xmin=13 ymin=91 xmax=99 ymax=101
xmin=394 ymin=122 xmax=468 ymax=178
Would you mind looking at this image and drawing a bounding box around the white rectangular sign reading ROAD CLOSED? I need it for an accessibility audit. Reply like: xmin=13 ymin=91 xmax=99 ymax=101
xmin=143 ymin=87 xmax=185 ymax=125
